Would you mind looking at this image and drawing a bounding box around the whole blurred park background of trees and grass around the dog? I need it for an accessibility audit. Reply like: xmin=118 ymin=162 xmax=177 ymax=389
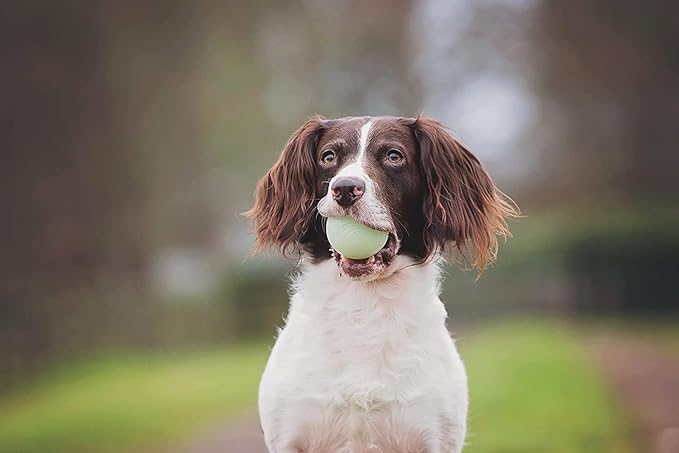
xmin=0 ymin=0 xmax=679 ymax=453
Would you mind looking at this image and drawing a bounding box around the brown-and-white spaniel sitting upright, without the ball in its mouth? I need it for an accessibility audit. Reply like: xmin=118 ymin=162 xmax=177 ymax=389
xmin=246 ymin=116 xmax=517 ymax=453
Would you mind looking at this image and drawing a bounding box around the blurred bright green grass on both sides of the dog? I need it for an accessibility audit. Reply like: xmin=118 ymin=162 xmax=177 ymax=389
xmin=0 ymin=322 xmax=632 ymax=453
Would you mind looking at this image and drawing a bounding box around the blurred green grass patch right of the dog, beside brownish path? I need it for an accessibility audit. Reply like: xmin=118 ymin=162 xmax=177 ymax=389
xmin=458 ymin=322 xmax=632 ymax=453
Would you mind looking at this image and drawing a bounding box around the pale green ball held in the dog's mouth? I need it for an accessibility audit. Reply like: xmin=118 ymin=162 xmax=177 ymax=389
xmin=325 ymin=216 xmax=389 ymax=260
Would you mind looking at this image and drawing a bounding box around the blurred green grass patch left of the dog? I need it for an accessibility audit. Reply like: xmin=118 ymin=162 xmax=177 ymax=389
xmin=0 ymin=345 xmax=268 ymax=453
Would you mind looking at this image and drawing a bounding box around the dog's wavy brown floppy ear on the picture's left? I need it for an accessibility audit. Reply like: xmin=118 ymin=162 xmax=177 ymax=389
xmin=245 ymin=117 xmax=328 ymax=253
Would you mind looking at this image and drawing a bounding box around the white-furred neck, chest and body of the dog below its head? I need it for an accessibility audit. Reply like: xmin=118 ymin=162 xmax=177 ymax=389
xmin=259 ymin=256 xmax=467 ymax=453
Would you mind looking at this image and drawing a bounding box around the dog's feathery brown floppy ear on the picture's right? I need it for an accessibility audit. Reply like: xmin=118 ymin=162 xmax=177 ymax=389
xmin=411 ymin=116 xmax=519 ymax=271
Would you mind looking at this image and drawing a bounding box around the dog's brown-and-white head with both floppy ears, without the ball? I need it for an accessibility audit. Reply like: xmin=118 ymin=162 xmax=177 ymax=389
xmin=248 ymin=117 xmax=516 ymax=280
